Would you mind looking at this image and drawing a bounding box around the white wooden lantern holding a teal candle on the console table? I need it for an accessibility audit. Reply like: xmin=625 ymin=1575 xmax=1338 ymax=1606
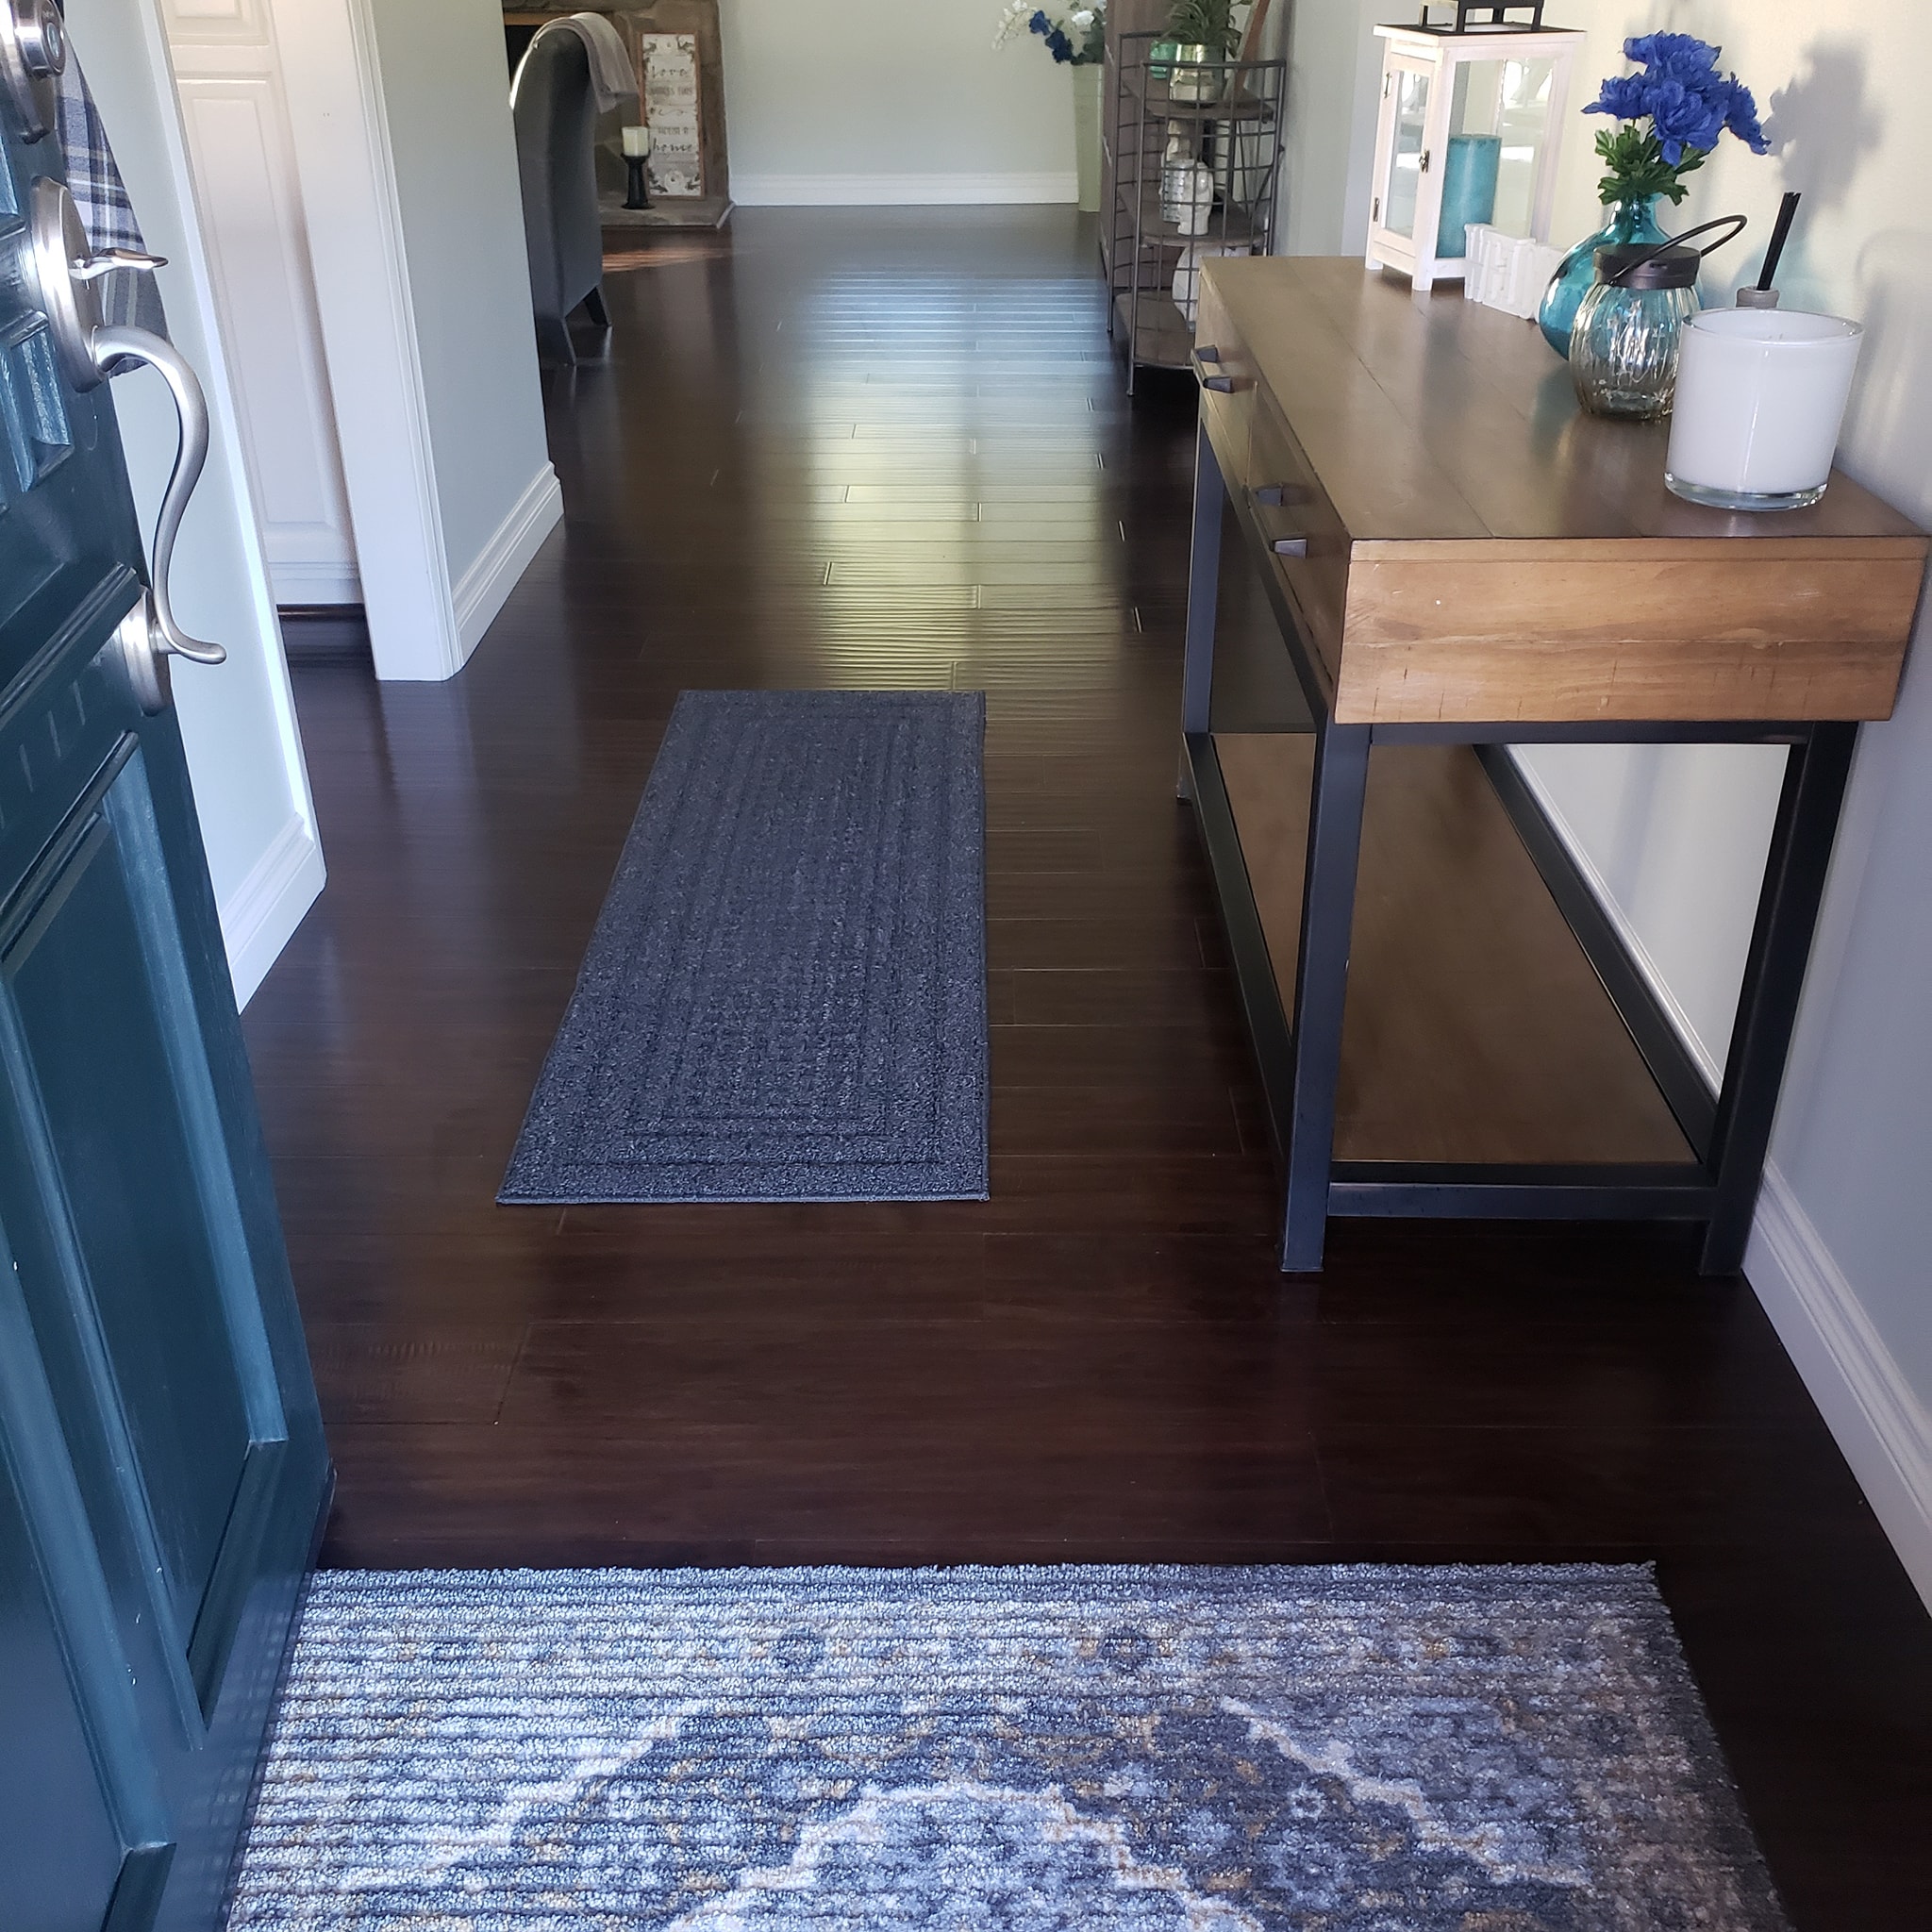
xmin=1368 ymin=0 xmax=1588 ymax=291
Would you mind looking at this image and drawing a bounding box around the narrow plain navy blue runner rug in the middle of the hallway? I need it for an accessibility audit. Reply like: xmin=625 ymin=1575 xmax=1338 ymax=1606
xmin=496 ymin=691 xmax=988 ymax=1202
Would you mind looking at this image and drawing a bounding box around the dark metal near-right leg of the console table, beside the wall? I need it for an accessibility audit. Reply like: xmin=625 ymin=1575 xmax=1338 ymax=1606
xmin=1700 ymin=724 xmax=1858 ymax=1275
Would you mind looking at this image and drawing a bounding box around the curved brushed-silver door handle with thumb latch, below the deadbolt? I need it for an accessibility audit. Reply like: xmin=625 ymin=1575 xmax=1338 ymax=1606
xmin=24 ymin=177 xmax=228 ymax=709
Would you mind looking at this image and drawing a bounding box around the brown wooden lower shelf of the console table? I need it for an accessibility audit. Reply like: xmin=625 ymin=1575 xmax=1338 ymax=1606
xmin=1191 ymin=732 xmax=1709 ymax=1182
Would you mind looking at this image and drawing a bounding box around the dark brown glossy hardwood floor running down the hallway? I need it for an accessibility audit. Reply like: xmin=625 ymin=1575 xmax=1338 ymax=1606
xmin=247 ymin=208 xmax=1932 ymax=1928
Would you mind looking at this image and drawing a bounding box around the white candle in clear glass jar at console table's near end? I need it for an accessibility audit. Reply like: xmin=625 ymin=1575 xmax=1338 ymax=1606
xmin=1663 ymin=309 xmax=1864 ymax=510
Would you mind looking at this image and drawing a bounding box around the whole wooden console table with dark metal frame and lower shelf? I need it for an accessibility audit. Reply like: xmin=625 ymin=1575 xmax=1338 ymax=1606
xmin=1182 ymin=257 xmax=1928 ymax=1274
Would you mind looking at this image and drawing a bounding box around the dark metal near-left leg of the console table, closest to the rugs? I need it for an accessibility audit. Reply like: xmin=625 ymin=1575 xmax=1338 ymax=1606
xmin=1281 ymin=721 xmax=1370 ymax=1274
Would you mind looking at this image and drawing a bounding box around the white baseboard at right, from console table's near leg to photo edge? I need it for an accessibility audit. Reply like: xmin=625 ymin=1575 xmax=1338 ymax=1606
xmin=1744 ymin=1167 xmax=1932 ymax=1609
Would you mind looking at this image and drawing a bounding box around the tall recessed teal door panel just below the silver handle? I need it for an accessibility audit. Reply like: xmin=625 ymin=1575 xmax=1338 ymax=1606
xmin=0 ymin=740 xmax=288 ymax=1706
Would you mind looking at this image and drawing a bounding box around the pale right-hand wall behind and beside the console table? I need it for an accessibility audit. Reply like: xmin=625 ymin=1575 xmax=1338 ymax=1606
xmin=1532 ymin=0 xmax=1932 ymax=1600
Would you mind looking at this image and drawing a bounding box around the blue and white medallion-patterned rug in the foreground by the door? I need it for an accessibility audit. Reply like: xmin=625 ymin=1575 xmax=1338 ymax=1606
xmin=230 ymin=1567 xmax=1783 ymax=1932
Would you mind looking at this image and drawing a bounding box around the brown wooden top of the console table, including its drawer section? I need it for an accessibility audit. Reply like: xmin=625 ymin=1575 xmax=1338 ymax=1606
xmin=1196 ymin=257 xmax=1932 ymax=723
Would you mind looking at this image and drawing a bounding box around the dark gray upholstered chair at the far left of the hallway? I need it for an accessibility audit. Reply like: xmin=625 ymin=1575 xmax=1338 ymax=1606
xmin=514 ymin=33 xmax=610 ymax=365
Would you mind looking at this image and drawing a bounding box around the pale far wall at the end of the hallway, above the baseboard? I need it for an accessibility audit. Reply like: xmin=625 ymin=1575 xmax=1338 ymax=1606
xmin=723 ymin=0 xmax=1074 ymax=205
